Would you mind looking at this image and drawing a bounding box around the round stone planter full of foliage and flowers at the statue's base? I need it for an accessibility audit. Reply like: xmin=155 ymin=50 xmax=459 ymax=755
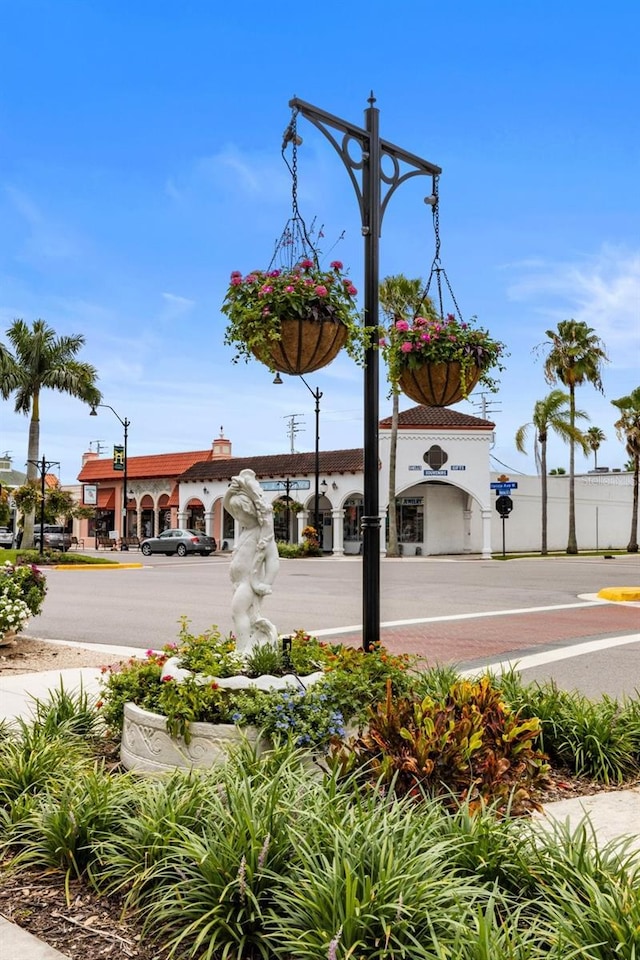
xmin=98 ymin=618 xmax=412 ymax=772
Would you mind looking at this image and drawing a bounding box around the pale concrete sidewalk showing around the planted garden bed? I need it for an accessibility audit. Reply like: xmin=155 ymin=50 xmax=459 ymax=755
xmin=0 ymin=644 xmax=640 ymax=960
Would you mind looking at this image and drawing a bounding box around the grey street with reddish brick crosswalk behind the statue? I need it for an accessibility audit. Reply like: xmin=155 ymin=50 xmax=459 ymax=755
xmin=28 ymin=553 xmax=640 ymax=695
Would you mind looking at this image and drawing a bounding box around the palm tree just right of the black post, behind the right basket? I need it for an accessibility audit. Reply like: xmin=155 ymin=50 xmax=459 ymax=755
xmin=378 ymin=273 xmax=436 ymax=557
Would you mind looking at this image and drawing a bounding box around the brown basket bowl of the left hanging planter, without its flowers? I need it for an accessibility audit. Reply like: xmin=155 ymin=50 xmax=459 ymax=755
xmin=252 ymin=318 xmax=349 ymax=376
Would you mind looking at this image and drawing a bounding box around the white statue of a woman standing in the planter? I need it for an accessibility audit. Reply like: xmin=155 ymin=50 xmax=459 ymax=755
xmin=224 ymin=470 xmax=280 ymax=653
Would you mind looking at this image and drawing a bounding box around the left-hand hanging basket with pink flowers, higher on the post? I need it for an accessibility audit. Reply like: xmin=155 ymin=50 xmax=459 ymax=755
xmin=222 ymin=258 xmax=363 ymax=375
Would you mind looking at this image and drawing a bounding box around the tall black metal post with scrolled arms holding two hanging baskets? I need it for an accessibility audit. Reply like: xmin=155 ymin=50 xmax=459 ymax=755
xmin=283 ymin=94 xmax=442 ymax=650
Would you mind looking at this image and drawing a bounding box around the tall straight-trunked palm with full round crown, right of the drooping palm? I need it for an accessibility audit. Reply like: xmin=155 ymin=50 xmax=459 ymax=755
xmin=544 ymin=320 xmax=609 ymax=554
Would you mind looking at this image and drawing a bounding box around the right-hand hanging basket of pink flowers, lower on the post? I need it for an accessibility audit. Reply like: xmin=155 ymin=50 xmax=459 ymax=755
xmin=379 ymin=313 xmax=505 ymax=407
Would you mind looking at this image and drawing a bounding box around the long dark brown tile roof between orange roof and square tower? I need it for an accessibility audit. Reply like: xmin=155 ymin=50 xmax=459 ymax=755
xmin=178 ymin=448 xmax=364 ymax=483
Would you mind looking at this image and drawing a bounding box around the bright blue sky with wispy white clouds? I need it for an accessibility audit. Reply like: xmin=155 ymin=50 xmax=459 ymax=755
xmin=0 ymin=0 xmax=640 ymax=482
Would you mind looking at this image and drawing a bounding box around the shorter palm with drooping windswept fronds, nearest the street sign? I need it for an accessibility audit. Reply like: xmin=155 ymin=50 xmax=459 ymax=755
xmin=515 ymin=390 xmax=588 ymax=556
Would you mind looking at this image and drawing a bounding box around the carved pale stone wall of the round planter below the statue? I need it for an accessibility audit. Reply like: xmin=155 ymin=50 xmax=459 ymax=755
xmin=120 ymin=703 xmax=266 ymax=773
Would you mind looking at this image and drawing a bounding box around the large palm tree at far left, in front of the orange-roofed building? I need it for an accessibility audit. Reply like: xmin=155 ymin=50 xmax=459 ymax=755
xmin=0 ymin=320 xmax=102 ymax=548
